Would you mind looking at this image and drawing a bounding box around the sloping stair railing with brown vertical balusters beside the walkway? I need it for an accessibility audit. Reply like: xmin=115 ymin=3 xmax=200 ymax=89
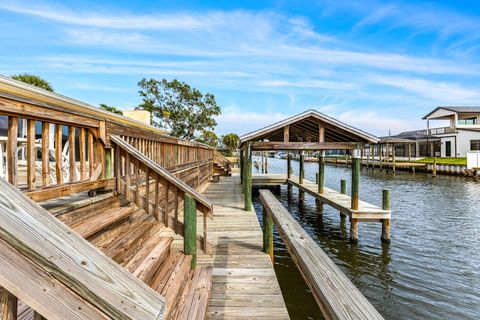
xmin=110 ymin=135 xmax=213 ymax=260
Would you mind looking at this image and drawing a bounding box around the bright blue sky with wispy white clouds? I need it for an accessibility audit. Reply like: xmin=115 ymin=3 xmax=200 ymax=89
xmin=0 ymin=0 xmax=480 ymax=135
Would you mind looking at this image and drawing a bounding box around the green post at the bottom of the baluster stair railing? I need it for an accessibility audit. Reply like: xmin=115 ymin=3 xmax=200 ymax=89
xmin=183 ymin=194 xmax=197 ymax=269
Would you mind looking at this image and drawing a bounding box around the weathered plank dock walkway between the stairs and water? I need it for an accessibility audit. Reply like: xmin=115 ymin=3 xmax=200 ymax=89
xmin=198 ymin=173 xmax=289 ymax=319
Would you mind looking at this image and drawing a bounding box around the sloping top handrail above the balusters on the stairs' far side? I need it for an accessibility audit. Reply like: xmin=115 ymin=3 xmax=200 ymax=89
xmin=110 ymin=135 xmax=213 ymax=217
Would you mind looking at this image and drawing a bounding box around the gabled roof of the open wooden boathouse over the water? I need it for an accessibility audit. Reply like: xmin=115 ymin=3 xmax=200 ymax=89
xmin=240 ymin=109 xmax=380 ymax=144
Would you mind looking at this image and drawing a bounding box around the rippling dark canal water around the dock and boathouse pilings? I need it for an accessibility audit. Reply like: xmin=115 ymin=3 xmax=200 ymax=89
xmin=253 ymin=157 xmax=480 ymax=319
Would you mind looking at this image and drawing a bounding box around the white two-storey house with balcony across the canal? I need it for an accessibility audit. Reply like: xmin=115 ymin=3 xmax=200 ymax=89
xmin=388 ymin=107 xmax=480 ymax=158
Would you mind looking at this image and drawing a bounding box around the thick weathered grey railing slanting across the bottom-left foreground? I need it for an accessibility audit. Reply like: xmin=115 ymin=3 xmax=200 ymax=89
xmin=0 ymin=178 xmax=166 ymax=320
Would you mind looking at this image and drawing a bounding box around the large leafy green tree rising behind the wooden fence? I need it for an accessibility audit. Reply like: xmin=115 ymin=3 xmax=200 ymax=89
xmin=137 ymin=78 xmax=221 ymax=140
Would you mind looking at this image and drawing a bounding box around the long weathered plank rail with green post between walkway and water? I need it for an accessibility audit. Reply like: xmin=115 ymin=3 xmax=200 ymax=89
xmin=260 ymin=190 xmax=383 ymax=320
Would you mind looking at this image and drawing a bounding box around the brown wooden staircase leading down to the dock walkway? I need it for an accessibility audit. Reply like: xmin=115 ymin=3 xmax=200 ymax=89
xmin=58 ymin=196 xmax=212 ymax=319
